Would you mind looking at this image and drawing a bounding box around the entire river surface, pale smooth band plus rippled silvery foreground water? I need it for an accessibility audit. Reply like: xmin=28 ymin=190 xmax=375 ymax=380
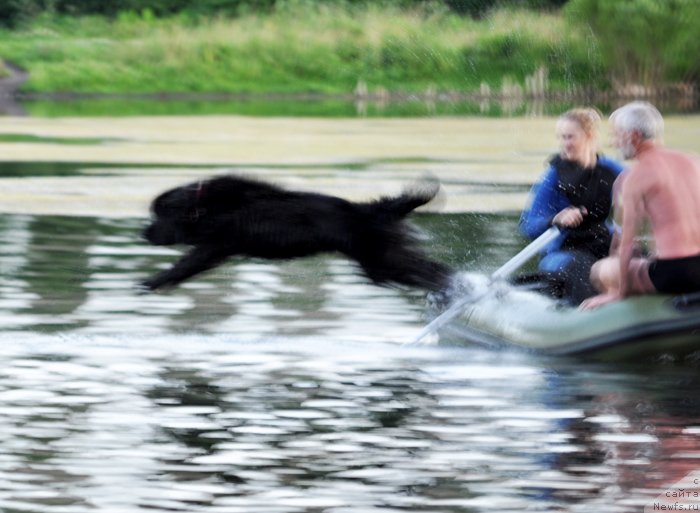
xmin=0 ymin=107 xmax=700 ymax=513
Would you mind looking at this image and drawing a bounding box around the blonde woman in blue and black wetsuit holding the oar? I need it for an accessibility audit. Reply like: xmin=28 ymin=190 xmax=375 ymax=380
xmin=520 ymin=108 xmax=623 ymax=304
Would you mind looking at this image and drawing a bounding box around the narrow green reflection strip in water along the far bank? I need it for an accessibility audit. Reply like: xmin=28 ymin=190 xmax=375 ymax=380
xmin=15 ymin=92 xmax=698 ymax=117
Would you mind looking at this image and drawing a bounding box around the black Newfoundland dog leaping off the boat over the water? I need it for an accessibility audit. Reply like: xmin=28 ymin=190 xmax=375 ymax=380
xmin=143 ymin=175 xmax=452 ymax=291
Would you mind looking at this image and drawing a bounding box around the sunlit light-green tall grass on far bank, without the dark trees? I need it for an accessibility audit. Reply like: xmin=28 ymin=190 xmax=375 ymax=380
xmin=0 ymin=3 xmax=605 ymax=94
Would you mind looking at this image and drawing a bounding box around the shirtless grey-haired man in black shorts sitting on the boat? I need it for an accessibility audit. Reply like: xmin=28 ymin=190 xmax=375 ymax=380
xmin=581 ymin=102 xmax=700 ymax=309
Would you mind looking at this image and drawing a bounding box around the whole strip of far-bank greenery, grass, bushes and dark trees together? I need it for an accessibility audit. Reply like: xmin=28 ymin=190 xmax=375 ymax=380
xmin=0 ymin=0 xmax=700 ymax=96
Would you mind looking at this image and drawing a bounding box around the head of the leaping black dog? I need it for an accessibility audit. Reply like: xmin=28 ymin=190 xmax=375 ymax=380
xmin=143 ymin=182 xmax=206 ymax=246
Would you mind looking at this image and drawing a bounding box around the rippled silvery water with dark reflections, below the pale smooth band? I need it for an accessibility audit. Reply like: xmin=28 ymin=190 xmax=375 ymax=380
xmin=0 ymin=215 xmax=700 ymax=513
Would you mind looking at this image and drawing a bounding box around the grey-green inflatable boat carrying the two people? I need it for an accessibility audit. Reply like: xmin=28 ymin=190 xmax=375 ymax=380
xmin=439 ymin=287 xmax=700 ymax=361
